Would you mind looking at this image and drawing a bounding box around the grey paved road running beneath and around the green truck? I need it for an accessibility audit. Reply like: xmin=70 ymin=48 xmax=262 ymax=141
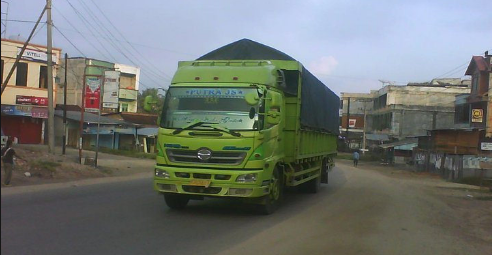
xmin=1 ymin=164 xmax=492 ymax=255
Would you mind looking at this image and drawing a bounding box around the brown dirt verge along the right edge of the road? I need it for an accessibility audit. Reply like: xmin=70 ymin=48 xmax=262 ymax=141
xmin=337 ymin=160 xmax=492 ymax=246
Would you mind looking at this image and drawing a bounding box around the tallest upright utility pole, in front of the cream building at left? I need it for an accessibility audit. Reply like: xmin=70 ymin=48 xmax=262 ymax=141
xmin=46 ymin=0 xmax=55 ymax=154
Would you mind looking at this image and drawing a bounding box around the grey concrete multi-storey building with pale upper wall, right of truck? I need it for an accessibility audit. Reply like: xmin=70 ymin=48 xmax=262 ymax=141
xmin=368 ymin=79 xmax=470 ymax=140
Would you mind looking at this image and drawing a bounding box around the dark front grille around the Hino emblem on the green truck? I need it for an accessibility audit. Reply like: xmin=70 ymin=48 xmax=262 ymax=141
xmin=166 ymin=149 xmax=246 ymax=165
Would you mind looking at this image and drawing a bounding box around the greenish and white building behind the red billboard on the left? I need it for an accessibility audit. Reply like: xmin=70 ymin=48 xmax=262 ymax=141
xmin=57 ymin=57 xmax=140 ymax=113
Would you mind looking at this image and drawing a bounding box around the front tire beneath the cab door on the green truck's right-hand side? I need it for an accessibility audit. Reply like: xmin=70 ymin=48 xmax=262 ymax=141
xmin=258 ymin=167 xmax=284 ymax=215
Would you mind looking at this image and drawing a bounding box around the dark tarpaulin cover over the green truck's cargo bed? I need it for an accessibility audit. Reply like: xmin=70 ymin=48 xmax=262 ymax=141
xmin=197 ymin=39 xmax=340 ymax=134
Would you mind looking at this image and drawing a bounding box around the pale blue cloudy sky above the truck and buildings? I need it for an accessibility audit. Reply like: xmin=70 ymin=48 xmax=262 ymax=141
xmin=2 ymin=0 xmax=492 ymax=94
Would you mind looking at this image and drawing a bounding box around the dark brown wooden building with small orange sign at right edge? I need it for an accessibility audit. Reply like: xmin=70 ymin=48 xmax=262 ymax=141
xmin=414 ymin=52 xmax=492 ymax=180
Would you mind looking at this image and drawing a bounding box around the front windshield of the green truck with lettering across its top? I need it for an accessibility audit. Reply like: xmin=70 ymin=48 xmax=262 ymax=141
xmin=160 ymin=88 xmax=258 ymax=130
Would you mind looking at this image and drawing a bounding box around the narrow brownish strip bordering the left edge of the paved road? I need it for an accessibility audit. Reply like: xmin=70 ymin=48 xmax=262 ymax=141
xmin=1 ymin=172 xmax=153 ymax=197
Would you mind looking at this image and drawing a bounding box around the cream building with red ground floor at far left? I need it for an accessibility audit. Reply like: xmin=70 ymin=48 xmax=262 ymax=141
xmin=0 ymin=39 xmax=62 ymax=144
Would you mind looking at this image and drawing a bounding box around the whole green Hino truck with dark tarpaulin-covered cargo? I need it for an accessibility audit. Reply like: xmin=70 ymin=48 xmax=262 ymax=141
xmin=154 ymin=39 xmax=339 ymax=214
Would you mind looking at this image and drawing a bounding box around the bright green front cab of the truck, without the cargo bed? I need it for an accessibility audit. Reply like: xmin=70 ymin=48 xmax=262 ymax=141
xmin=154 ymin=61 xmax=285 ymax=214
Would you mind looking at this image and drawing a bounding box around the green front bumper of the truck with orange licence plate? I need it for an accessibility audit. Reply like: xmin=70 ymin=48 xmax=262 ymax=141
xmin=154 ymin=166 xmax=269 ymax=198
